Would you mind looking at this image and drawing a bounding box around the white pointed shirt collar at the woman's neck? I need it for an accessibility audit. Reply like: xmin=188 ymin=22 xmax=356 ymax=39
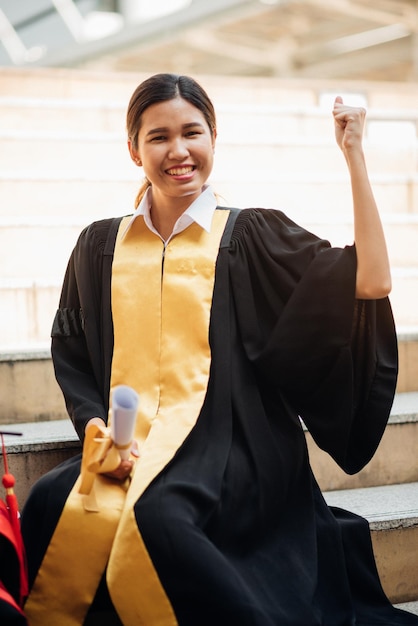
xmin=124 ymin=185 xmax=218 ymax=244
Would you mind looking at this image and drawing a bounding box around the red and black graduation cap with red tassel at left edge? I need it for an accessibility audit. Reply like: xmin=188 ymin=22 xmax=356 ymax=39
xmin=0 ymin=431 xmax=28 ymax=624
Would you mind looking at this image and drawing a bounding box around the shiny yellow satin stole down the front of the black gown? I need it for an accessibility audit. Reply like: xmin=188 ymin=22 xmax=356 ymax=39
xmin=25 ymin=211 xmax=229 ymax=626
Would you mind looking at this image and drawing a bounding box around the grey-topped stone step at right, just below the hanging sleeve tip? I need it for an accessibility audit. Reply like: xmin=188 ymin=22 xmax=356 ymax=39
xmin=324 ymin=482 xmax=418 ymax=602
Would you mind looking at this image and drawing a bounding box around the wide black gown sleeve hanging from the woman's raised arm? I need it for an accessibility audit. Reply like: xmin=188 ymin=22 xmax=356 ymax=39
xmin=230 ymin=209 xmax=398 ymax=473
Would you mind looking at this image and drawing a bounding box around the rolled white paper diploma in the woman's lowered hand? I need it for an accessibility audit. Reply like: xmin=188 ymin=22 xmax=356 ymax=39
xmin=110 ymin=385 xmax=139 ymax=460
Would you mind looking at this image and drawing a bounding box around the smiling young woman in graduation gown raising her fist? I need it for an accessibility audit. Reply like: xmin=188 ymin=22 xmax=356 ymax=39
xmin=22 ymin=74 xmax=418 ymax=626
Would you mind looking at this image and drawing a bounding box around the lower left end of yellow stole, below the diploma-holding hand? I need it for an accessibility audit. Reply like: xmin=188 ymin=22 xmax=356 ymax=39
xmin=25 ymin=458 xmax=126 ymax=626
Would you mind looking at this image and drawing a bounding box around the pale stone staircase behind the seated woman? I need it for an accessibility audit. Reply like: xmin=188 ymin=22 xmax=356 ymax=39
xmin=0 ymin=69 xmax=418 ymax=613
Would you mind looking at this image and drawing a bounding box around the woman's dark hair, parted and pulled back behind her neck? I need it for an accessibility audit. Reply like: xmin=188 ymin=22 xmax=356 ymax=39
xmin=126 ymin=74 xmax=216 ymax=207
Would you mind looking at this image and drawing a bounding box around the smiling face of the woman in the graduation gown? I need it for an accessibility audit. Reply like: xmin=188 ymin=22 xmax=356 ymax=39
xmin=129 ymin=97 xmax=215 ymax=204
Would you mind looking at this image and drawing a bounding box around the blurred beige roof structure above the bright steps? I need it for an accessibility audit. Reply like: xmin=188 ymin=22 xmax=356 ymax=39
xmin=0 ymin=0 xmax=418 ymax=82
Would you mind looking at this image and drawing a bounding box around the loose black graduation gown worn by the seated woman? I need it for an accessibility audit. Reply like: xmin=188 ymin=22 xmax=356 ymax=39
xmin=22 ymin=209 xmax=418 ymax=626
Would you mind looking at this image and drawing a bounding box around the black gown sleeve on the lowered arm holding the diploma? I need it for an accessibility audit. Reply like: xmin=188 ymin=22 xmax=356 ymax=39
xmin=51 ymin=220 xmax=119 ymax=440
